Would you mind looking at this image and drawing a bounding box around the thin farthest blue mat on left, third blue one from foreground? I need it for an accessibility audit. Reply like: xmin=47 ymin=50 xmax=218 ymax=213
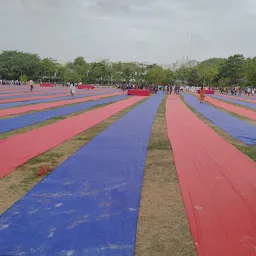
xmin=0 ymin=91 xmax=114 ymax=109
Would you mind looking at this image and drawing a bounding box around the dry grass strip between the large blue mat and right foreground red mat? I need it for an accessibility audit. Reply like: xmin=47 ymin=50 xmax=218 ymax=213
xmin=135 ymin=96 xmax=196 ymax=256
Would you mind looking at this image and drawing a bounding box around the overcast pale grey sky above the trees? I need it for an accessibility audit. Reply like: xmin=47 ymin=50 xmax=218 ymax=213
xmin=0 ymin=0 xmax=256 ymax=64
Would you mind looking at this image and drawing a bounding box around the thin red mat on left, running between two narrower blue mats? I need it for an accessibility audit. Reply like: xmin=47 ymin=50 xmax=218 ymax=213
xmin=0 ymin=92 xmax=123 ymax=117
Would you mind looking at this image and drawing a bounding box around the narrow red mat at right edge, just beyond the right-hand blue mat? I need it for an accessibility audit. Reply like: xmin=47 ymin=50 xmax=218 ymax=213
xmin=206 ymin=97 xmax=256 ymax=121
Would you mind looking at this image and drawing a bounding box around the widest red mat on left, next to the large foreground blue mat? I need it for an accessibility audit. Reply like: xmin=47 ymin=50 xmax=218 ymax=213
xmin=0 ymin=97 xmax=145 ymax=178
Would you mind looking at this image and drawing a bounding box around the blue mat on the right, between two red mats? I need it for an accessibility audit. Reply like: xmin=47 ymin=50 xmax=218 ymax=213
xmin=182 ymin=93 xmax=256 ymax=145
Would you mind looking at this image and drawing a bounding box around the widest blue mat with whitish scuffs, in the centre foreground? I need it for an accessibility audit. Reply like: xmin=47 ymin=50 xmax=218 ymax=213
xmin=0 ymin=95 xmax=163 ymax=256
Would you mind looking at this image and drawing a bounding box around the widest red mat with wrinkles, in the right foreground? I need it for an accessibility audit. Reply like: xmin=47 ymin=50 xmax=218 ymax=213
xmin=166 ymin=96 xmax=256 ymax=256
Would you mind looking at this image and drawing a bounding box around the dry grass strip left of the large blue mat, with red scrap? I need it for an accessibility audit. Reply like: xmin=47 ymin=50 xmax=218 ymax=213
xmin=0 ymin=99 xmax=146 ymax=214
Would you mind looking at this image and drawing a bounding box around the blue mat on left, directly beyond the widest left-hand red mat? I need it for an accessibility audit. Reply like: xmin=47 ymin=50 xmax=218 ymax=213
xmin=0 ymin=95 xmax=127 ymax=134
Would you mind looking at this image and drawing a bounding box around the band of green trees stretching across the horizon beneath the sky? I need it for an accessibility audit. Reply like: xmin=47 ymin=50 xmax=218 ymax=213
xmin=0 ymin=51 xmax=256 ymax=87
